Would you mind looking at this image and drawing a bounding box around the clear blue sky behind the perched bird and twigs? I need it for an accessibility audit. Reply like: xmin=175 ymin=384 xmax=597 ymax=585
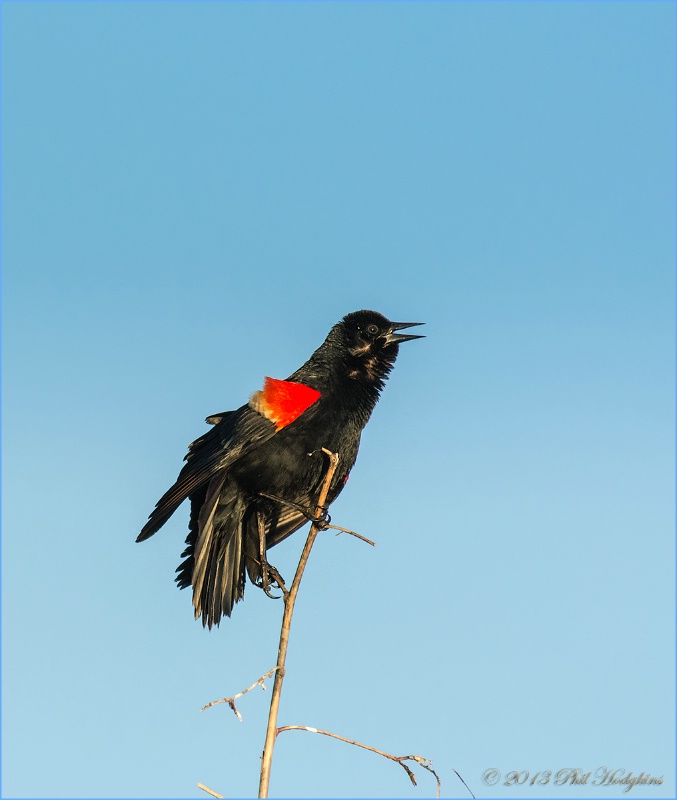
xmin=2 ymin=2 xmax=675 ymax=798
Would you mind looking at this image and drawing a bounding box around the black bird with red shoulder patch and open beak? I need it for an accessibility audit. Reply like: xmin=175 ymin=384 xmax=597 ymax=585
xmin=136 ymin=311 xmax=423 ymax=628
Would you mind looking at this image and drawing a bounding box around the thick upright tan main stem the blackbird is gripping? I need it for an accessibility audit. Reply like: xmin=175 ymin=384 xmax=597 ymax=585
xmin=259 ymin=447 xmax=339 ymax=797
